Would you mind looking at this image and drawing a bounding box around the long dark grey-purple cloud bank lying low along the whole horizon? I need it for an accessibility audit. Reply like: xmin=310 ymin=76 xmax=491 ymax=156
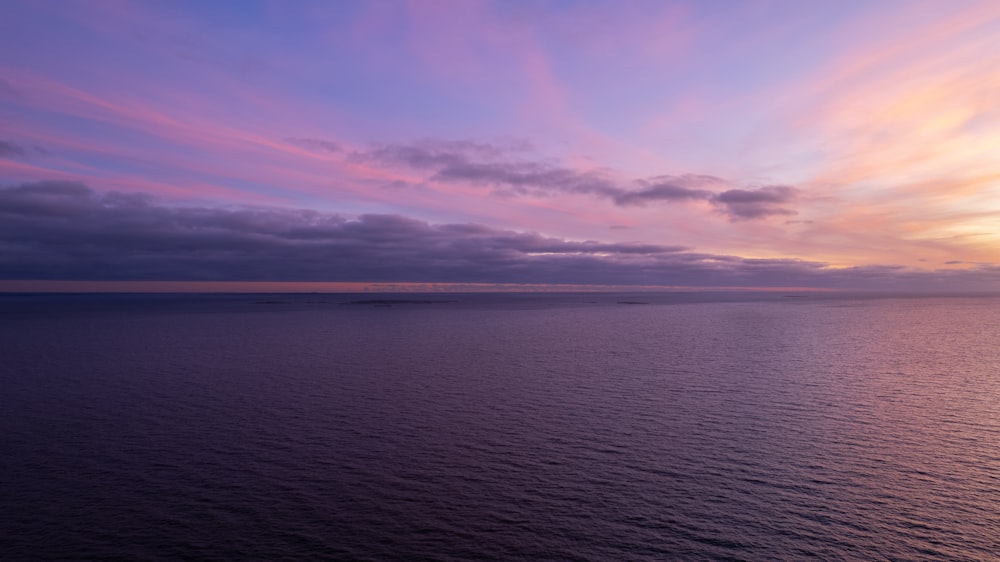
xmin=0 ymin=181 xmax=1000 ymax=290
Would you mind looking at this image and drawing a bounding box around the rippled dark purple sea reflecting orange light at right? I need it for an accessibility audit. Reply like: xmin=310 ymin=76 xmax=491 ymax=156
xmin=0 ymin=294 xmax=1000 ymax=560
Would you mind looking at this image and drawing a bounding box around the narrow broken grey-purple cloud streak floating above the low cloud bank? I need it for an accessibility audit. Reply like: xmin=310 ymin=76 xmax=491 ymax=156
xmin=352 ymin=140 xmax=797 ymax=221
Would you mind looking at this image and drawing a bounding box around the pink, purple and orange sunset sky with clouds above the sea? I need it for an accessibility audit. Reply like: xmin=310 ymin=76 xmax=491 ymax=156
xmin=0 ymin=0 xmax=1000 ymax=291
